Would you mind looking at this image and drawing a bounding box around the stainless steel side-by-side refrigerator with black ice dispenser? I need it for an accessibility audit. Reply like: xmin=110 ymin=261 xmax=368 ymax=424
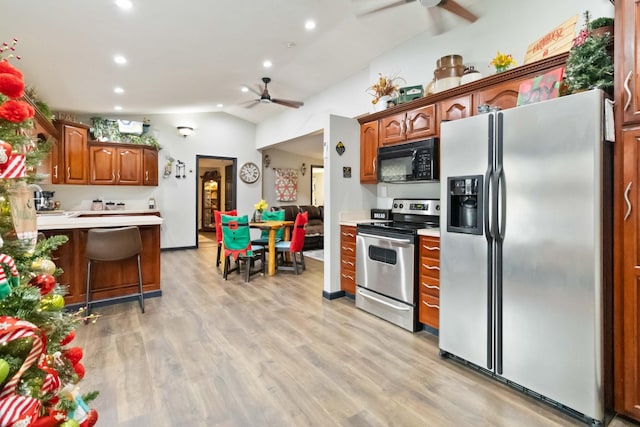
xmin=439 ymin=90 xmax=611 ymax=421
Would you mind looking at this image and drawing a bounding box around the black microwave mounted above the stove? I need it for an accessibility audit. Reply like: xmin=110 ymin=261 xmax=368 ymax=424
xmin=378 ymin=138 xmax=439 ymax=183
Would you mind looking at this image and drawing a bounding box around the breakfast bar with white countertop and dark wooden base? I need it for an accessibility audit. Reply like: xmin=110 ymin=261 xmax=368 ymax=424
xmin=38 ymin=211 xmax=163 ymax=305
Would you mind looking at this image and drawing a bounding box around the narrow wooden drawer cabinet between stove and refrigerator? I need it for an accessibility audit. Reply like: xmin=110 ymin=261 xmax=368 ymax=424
xmin=418 ymin=236 xmax=440 ymax=329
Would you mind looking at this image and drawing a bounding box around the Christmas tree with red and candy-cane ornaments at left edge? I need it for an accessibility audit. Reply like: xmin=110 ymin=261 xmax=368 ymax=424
xmin=0 ymin=39 xmax=98 ymax=427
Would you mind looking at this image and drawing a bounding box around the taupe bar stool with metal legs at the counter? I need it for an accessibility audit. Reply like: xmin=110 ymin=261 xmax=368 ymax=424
xmin=85 ymin=226 xmax=144 ymax=314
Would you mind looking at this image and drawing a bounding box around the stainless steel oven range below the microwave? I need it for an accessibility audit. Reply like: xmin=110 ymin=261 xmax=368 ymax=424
xmin=356 ymin=199 xmax=440 ymax=331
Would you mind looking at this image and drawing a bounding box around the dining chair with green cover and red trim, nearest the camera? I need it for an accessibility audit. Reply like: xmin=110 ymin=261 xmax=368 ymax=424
xmin=220 ymin=214 xmax=266 ymax=282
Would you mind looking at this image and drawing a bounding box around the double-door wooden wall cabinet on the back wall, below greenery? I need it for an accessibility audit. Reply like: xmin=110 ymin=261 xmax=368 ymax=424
xmin=89 ymin=144 xmax=143 ymax=185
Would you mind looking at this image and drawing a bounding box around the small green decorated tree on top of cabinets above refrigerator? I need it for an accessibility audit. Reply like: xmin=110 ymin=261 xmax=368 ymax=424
xmin=565 ymin=12 xmax=613 ymax=95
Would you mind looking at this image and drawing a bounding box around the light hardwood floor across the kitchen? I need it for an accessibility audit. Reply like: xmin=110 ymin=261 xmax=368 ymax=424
xmin=75 ymin=246 xmax=633 ymax=427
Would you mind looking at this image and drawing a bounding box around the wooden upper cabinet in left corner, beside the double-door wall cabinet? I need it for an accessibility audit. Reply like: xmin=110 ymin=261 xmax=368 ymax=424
xmin=51 ymin=120 xmax=89 ymax=184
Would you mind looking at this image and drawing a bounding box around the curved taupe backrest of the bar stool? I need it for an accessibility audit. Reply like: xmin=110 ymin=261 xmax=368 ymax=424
xmin=86 ymin=226 xmax=142 ymax=261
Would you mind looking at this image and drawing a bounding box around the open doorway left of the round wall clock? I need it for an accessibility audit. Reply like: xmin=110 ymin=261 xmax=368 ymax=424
xmin=196 ymin=155 xmax=237 ymax=248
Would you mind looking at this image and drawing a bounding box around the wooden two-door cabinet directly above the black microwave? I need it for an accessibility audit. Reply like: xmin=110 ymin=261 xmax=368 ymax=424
xmin=378 ymin=104 xmax=437 ymax=146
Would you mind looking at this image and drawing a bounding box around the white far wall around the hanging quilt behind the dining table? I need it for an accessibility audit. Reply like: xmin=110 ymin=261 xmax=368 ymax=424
xmin=262 ymin=149 xmax=322 ymax=207
